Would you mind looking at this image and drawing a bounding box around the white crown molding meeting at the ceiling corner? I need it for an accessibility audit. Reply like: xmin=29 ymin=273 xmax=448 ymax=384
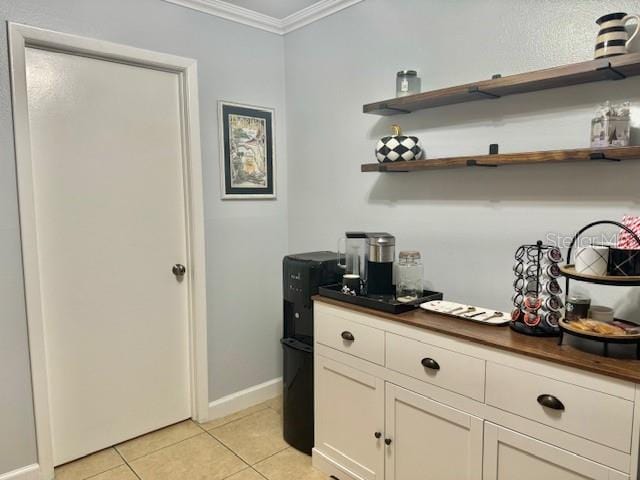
xmin=164 ymin=0 xmax=363 ymax=35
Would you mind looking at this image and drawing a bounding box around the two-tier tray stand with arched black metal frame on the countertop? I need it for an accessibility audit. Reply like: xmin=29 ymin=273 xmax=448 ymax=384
xmin=558 ymin=220 xmax=640 ymax=360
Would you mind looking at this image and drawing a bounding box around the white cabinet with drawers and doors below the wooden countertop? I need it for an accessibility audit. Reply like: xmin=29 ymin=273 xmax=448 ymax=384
xmin=313 ymin=302 xmax=640 ymax=480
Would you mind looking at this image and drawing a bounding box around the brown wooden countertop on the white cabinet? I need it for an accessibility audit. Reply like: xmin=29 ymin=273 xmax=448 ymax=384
xmin=313 ymin=295 xmax=640 ymax=383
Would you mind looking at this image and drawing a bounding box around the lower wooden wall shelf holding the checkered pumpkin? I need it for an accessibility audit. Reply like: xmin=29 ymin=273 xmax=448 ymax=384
xmin=361 ymin=147 xmax=640 ymax=172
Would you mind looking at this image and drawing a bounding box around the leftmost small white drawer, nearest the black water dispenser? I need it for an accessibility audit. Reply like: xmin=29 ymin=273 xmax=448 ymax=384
xmin=315 ymin=311 xmax=384 ymax=365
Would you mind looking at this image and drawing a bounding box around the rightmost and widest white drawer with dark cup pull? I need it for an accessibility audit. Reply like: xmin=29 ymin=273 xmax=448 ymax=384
xmin=486 ymin=362 xmax=633 ymax=453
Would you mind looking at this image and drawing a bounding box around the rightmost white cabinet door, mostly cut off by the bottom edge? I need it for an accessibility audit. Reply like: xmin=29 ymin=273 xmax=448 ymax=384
xmin=484 ymin=422 xmax=629 ymax=480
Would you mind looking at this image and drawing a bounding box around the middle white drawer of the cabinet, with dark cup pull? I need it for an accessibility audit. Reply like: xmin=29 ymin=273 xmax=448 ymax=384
xmin=386 ymin=333 xmax=485 ymax=402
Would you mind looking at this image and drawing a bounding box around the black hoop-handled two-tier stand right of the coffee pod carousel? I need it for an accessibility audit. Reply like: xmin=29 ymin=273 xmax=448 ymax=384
xmin=558 ymin=220 xmax=640 ymax=360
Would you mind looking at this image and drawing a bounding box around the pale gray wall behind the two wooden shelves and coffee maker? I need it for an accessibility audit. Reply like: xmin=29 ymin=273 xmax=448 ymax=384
xmin=285 ymin=0 xmax=640 ymax=314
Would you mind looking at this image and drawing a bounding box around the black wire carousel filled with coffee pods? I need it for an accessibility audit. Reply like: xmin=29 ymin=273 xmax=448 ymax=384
xmin=509 ymin=240 xmax=564 ymax=337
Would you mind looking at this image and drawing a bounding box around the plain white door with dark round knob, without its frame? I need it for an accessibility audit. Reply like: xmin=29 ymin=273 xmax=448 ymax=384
xmin=26 ymin=48 xmax=191 ymax=465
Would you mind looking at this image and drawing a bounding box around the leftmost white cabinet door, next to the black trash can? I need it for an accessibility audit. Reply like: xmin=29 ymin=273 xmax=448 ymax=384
xmin=315 ymin=356 xmax=384 ymax=480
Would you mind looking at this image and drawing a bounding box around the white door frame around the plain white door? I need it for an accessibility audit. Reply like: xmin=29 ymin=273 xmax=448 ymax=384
xmin=8 ymin=22 xmax=209 ymax=479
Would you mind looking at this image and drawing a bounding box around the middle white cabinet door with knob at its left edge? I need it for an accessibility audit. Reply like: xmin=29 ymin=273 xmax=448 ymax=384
xmin=385 ymin=383 xmax=480 ymax=480
